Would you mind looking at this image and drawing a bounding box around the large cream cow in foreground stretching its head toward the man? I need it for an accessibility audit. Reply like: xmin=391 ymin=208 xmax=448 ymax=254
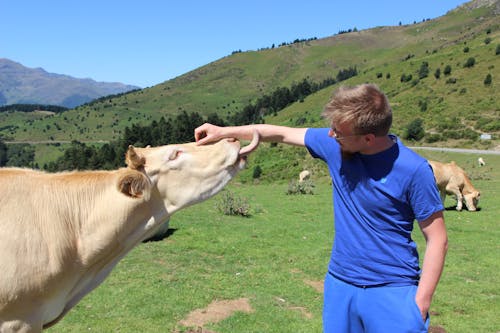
xmin=0 ymin=133 xmax=259 ymax=333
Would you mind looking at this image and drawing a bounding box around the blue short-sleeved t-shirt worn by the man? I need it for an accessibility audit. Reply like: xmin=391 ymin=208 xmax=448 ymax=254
xmin=305 ymin=128 xmax=444 ymax=286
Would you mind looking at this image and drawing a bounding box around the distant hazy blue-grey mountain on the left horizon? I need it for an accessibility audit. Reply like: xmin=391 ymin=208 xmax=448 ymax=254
xmin=0 ymin=58 xmax=139 ymax=108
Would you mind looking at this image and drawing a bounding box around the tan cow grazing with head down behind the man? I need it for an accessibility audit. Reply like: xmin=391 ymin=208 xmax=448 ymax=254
xmin=429 ymin=161 xmax=481 ymax=212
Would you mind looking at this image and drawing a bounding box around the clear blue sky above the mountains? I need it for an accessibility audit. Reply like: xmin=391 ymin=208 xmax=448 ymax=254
xmin=0 ymin=0 xmax=467 ymax=88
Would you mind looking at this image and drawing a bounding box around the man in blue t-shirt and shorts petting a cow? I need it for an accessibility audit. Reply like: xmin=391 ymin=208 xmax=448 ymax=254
xmin=195 ymin=84 xmax=447 ymax=333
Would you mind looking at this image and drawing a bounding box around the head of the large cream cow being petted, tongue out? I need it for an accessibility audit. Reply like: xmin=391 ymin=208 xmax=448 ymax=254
xmin=119 ymin=132 xmax=259 ymax=214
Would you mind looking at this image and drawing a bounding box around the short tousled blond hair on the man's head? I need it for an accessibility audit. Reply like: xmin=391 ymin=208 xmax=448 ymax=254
xmin=323 ymin=84 xmax=392 ymax=136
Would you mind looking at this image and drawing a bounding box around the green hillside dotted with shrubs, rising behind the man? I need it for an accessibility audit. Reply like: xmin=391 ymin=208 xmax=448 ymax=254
xmin=0 ymin=0 xmax=500 ymax=163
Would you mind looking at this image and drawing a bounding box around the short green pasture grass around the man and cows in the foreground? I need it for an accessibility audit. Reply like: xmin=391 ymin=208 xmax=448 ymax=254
xmin=48 ymin=151 xmax=500 ymax=333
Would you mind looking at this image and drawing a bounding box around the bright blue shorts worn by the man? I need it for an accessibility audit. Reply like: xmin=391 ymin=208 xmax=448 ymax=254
xmin=323 ymin=273 xmax=430 ymax=333
